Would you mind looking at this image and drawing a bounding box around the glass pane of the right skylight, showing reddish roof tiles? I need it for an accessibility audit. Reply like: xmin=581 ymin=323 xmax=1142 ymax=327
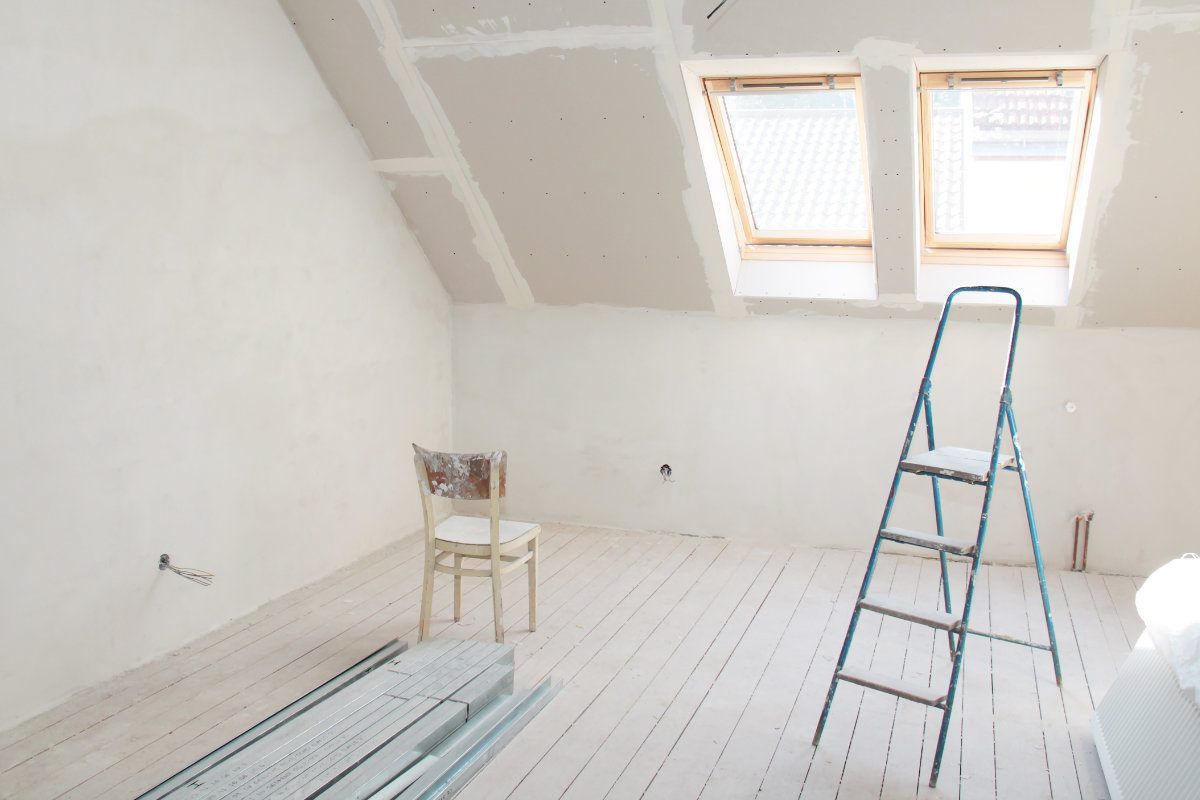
xmin=929 ymin=88 xmax=1084 ymax=239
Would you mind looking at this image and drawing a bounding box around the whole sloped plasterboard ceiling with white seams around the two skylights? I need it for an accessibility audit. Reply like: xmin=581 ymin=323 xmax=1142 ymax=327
xmin=281 ymin=0 xmax=1200 ymax=327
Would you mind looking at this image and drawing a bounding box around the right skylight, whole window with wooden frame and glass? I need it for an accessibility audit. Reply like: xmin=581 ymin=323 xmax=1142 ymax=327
xmin=920 ymin=70 xmax=1094 ymax=252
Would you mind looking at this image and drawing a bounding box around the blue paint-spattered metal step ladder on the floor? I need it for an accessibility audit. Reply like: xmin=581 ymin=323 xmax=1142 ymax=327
xmin=812 ymin=287 xmax=1062 ymax=787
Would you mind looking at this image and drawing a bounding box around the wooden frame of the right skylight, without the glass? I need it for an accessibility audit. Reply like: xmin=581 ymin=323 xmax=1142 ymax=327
xmin=917 ymin=70 xmax=1096 ymax=256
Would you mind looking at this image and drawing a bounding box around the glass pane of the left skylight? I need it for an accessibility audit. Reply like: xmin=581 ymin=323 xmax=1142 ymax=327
xmin=724 ymin=89 xmax=866 ymax=236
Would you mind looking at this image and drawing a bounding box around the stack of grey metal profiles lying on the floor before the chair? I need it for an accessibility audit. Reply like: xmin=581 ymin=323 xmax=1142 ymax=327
xmin=139 ymin=639 xmax=554 ymax=800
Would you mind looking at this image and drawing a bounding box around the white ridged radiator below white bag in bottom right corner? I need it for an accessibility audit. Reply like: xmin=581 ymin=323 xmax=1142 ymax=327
xmin=1092 ymin=633 xmax=1200 ymax=800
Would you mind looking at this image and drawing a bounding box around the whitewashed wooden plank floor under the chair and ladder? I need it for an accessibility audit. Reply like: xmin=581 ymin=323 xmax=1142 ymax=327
xmin=0 ymin=527 xmax=1140 ymax=800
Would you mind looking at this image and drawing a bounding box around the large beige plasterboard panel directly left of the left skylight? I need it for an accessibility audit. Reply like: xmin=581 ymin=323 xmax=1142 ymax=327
xmin=420 ymin=49 xmax=713 ymax=311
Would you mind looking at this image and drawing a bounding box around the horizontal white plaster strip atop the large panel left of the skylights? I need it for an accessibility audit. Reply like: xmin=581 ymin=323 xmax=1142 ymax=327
xmin=403 ymin=25 xmax=655 ymax=61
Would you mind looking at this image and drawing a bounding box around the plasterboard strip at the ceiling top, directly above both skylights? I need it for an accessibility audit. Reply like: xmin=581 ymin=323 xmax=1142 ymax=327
xmin=684 ymin=0 xmax=1094 ymax=55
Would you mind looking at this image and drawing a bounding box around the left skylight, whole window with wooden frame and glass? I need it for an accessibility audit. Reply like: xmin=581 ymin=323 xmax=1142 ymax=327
xmin=704 ymin=76 xmax=871 ymax=251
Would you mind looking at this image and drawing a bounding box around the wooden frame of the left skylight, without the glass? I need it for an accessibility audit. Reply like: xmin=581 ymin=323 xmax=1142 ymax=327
xmin=702 ymin=74 xmax=871 ymax=256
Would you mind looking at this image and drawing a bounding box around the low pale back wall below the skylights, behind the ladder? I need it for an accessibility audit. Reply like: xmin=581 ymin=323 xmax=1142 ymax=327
xmin=454 ymin=305 xmax=1200 ymax=575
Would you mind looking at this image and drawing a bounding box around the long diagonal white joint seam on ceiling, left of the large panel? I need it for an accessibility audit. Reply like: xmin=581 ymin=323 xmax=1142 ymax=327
xmin=359 ymin=0 xmax=533 ymax=306
